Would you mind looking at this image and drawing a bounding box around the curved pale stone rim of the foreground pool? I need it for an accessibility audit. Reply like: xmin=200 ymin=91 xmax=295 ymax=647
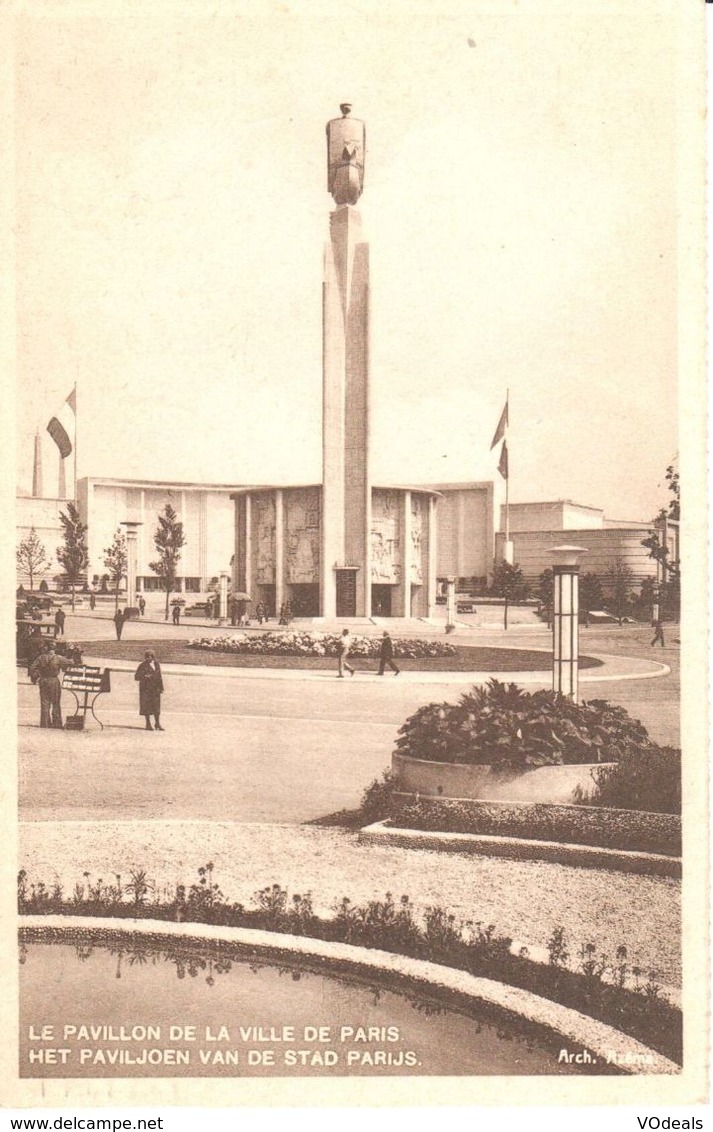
xmin=19 ymin=916 xmax=681 ymax=1075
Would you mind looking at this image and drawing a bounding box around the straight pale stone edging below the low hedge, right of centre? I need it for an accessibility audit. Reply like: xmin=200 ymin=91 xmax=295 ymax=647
xmin=359 ymin=821 xmax=682 ymax=880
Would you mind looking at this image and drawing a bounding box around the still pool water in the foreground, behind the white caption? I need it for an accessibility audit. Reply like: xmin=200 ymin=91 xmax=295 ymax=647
xmin=20 ymin=932 xmax=615 ymax=1077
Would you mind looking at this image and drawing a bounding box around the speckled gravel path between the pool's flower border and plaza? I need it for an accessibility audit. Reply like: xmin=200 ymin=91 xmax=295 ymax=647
xmin=19 ymin=821 xmax=680 ymax=986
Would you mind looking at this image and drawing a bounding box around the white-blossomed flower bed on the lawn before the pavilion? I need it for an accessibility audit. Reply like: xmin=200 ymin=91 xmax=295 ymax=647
xmin=189 ymin=632 xmax=456 ymax=660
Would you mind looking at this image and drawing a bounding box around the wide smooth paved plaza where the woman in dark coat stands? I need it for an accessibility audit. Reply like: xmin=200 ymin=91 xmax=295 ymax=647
xmin=18 ymin=617 xmax=679 ymax=822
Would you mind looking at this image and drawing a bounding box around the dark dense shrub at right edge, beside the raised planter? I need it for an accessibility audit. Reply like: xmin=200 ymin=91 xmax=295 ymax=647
xmin=575 ymin=744 xmax=681 ymax=814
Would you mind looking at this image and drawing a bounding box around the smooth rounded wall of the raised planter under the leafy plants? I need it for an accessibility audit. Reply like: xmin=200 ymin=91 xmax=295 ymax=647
xmin=392 ymin=752 xmax=611 ymax=803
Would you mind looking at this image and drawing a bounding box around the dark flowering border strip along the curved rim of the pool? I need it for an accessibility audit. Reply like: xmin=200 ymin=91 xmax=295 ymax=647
xmin=17 ymin=863 xmax=681 ymax=1062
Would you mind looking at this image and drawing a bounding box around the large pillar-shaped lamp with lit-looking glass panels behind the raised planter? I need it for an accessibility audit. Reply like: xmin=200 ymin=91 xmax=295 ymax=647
xmin=550 ymin=547 xmax=586 ymax=702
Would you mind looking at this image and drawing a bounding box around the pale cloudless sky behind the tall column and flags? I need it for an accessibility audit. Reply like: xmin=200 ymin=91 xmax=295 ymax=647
xmin=15 ymin=0 xmax=681 ymax=520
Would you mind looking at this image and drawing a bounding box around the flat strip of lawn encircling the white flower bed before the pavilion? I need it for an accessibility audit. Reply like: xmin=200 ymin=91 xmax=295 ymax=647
xmin=81 ymin=637 xmax=602 ymax=672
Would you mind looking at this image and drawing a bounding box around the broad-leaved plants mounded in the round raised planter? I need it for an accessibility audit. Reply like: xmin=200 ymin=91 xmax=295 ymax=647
xmin=396 ymin=679 xmax=652 ymax=770
